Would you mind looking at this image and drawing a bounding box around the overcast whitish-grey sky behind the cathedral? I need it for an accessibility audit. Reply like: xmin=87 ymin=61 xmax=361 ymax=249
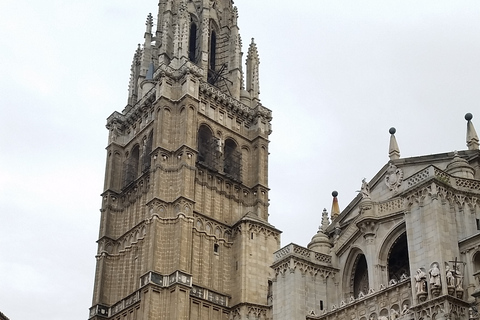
xmin=0 ymin=0 xmax=480 ymax=320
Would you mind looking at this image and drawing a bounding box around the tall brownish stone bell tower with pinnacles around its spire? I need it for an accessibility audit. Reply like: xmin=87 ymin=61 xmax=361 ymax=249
xmin=89 ymin=0 xmax=280 ymax=320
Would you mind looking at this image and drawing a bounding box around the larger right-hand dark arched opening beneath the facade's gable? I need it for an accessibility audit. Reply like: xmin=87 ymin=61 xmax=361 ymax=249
xmin=387 ymin=232 xmax=410 ymax=281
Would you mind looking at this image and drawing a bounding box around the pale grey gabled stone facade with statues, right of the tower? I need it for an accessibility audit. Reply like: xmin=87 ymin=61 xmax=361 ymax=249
xmin=273 ymin=119 xmax=480 ymax=320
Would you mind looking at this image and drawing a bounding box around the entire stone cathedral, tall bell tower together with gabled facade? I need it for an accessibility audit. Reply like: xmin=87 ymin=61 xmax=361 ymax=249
xmin=89 ymin=0 xmax=480 ymax=320
